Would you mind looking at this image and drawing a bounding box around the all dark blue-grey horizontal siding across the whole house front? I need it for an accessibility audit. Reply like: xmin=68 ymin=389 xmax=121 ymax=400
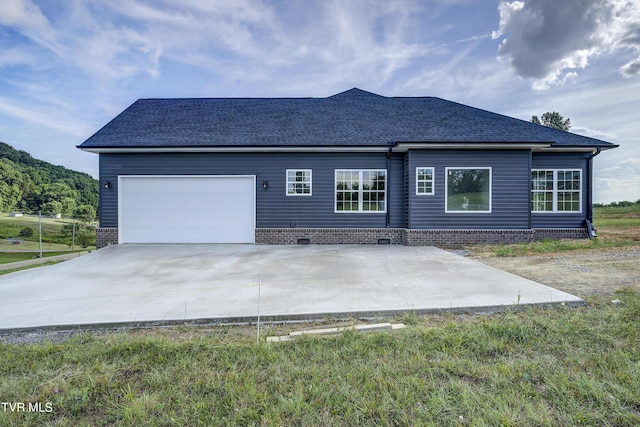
xmin=100 ymin=150 xmax=589 ymax=229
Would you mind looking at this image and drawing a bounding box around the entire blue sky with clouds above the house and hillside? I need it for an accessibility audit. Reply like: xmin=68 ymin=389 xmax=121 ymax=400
xmin=0 ymin=0 xmax=640 ymax=202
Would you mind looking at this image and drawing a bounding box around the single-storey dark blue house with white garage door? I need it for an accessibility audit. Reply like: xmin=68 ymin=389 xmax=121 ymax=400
xmin=78 ymin=89 xmax=616 ymax=247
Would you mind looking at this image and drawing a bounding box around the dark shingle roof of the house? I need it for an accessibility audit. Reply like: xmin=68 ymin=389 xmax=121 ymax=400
xmin=79 ymin=89 xmax=615 ymax=149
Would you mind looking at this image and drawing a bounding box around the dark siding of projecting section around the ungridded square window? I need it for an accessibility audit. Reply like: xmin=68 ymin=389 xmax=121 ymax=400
xmin=407 ymin=150 xmax=531 ymax=229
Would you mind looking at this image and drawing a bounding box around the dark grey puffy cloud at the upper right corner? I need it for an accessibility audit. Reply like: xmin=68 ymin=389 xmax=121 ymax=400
xmin=493 ymin=0 xmax=640 ymax=89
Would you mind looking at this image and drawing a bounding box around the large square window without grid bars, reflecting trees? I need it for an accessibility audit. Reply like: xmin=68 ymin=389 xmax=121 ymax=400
xmin=445 ymin=168 xmax=491 ymax=213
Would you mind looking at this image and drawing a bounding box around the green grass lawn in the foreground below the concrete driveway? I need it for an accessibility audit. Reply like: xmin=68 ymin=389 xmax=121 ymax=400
xmin=0 ymin=290 xmax=640 ymax=426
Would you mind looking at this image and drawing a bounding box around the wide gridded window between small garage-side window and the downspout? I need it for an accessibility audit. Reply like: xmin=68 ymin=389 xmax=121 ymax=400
xmin=335 ymin=169 xmax=387 ymax=212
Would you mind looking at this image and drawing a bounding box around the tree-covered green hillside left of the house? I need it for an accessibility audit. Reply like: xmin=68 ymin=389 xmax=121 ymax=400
xmin=0 ymin=142 xmax=99 ymax=217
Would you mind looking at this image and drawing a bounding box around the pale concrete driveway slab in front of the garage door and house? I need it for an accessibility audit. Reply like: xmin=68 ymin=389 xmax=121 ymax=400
xmin=0 ymin=244 xmax=583 ymax=330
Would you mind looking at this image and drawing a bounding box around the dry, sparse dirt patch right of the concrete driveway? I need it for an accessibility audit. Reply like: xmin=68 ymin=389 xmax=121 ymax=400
xmin=473 ymin=247 xmax=640 ymax=297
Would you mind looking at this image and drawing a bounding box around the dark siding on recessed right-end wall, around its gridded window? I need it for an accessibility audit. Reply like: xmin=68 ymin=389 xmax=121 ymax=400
xmin=531 ymin=153 xmax=590 ymax=228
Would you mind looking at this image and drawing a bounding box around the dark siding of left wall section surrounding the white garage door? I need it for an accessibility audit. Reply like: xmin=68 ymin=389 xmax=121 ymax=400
xmin=100 ymin=153 xmax=404 ymax=228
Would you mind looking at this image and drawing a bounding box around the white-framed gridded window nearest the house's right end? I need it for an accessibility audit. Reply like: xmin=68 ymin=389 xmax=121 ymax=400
xmin=531 ymin=169 xmax=582 ymax=212
